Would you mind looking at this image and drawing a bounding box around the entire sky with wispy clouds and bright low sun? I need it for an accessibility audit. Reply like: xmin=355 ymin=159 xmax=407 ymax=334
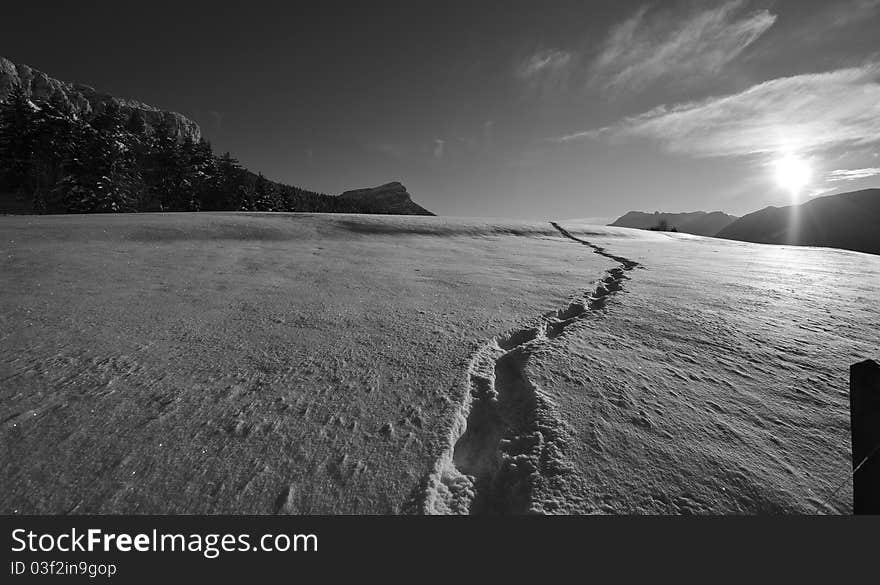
xmin=0 ymin=0 xmax=880 ymax=220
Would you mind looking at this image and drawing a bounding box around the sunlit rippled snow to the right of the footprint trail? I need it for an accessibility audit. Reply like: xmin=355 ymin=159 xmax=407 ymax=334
xmin=532 ymin=228 xmax=880 ymax=513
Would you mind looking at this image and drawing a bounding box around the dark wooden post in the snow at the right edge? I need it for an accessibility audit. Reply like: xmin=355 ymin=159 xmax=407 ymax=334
xmin=849 ymin=360 xmax=880 ymax=514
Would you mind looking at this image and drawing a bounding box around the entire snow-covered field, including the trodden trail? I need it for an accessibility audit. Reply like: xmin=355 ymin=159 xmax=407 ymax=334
xmin=0 ymin=213 xmax=880 ymax=513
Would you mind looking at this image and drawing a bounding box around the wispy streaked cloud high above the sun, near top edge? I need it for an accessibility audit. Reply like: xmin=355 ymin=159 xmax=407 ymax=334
xmin=592 ymin=0 xmax=776 ymax=93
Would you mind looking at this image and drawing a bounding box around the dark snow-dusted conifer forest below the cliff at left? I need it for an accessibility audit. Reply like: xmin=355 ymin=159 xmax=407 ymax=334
xmin=0 ymin=86 xmax=382 ymax=213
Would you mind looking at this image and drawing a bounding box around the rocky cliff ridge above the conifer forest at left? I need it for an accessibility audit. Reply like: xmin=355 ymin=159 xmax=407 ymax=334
xmin=0 ymin=57 xmax=202 ymax=142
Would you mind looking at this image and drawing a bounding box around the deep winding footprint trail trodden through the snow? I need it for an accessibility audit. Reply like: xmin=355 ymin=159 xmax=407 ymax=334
xmin=419 ymin=222 xmax=638 ymax=514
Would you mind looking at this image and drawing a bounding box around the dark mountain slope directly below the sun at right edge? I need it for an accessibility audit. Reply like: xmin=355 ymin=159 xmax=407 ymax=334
xmin=717 ymin=189 xmax=880 ymax=254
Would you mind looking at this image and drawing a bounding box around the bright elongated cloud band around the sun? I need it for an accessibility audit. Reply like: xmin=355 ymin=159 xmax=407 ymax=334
xmin=553 ymin=63 xmax=880 ymax=157
